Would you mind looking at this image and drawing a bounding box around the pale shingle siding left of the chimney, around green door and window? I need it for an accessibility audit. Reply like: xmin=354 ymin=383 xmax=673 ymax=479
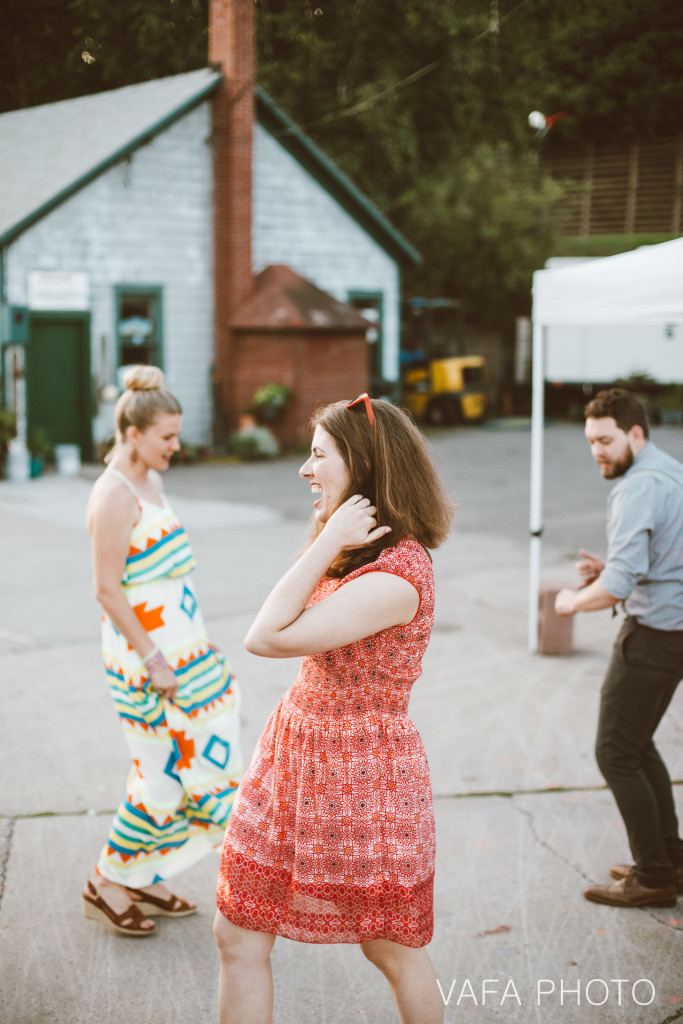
xmin=7 ymin=102 xmax=213 ymax=443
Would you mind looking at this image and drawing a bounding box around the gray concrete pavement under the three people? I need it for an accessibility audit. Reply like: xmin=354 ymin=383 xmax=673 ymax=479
xmin=0 ymin=425 xmax=683 ymax=1024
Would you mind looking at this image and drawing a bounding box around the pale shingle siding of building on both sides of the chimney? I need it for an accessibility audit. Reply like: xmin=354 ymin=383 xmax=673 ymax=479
xmin=6 ymin=101 xmax=399 ymax=444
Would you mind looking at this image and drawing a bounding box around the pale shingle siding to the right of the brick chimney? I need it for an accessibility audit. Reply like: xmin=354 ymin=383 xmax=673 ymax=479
xmin=252 ymin=125 xmax=399 ymax=381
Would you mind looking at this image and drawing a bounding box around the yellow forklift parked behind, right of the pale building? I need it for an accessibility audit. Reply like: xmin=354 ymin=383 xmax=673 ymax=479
xmin=401 ymin=299 xmax=488 ymax=426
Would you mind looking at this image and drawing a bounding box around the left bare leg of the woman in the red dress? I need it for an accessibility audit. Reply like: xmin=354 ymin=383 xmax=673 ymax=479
xmin=213 ymin=911 xmax=275 ymax=1024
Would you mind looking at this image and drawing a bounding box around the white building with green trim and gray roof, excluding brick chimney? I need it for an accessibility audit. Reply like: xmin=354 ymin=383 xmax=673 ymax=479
xmin=0 ymin=69 xmax=419 ymax=458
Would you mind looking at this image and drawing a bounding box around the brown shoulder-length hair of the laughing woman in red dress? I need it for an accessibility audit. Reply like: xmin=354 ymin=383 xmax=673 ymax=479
xmin=310 ymin=399 xmax=453 ymax=577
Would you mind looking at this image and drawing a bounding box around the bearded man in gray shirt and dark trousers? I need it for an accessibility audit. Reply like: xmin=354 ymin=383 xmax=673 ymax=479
xmin=555 ymin=388 xmax=683 ymax=906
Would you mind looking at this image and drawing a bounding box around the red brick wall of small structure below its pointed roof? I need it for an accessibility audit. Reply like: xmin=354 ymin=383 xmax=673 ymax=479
xmin=228 ymin=331 xmax=368 ymax=449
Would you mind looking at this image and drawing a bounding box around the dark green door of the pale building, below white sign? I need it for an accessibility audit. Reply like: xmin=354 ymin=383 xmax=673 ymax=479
xmin=27 ymin=313 xmax=91 ymax=460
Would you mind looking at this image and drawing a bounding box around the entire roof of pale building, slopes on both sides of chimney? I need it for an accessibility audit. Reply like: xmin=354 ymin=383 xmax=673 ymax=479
xmin=0 ymin=68 xmax=420 ymax=262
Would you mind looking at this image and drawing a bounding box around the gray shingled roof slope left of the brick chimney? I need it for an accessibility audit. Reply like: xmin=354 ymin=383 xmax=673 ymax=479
xmin=0 ymin=68 xmax=221 ymax=243
